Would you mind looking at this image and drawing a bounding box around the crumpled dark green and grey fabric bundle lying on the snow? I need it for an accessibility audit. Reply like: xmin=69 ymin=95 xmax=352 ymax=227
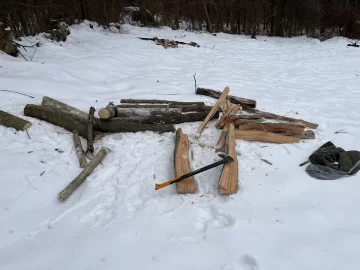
xmin=306 ymin=141 xmax=360 ymax=180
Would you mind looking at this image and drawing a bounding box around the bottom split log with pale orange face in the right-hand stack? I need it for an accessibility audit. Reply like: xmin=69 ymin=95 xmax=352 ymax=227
xmin=235 ymin=130 xmax=300 ymax=143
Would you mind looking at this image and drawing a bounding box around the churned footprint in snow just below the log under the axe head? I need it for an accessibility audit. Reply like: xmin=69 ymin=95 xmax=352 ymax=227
xmin=195 ymin=206 xmax=235 ymax=232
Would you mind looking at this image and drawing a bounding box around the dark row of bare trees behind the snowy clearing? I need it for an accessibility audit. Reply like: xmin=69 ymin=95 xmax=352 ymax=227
xmin=0 ymin=0 xmax=360 ymax=38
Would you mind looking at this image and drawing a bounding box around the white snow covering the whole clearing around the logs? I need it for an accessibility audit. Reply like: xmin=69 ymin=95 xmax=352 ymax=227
xmin=0 ymin=22 xmax=360 ymax=270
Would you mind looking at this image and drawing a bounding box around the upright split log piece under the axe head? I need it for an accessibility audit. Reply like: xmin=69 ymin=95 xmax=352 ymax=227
xmin=218 ymin=123 xmax=238 ymax=195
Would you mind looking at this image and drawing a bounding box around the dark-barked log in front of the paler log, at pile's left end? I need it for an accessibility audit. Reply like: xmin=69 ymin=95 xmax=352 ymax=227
xmin=24 ymin=104 xmax=104 ymax=141
